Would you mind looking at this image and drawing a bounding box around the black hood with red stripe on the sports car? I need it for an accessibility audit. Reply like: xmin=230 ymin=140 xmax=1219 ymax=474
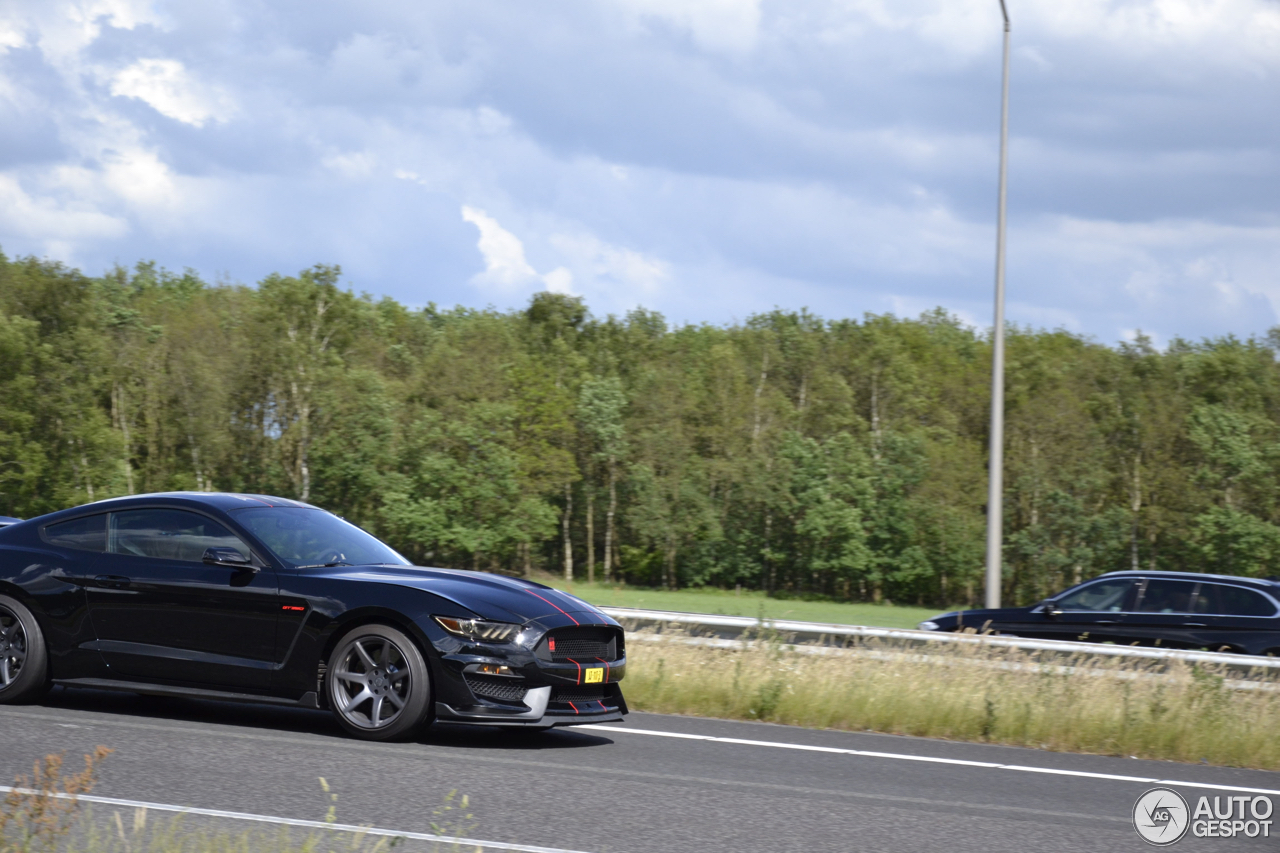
xmin=308 ymin=566 xmax=617 ymax=625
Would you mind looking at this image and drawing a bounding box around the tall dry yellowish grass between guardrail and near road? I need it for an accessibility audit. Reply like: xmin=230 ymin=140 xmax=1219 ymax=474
xmin=626 ymin=634 xmax=1280 ymax=770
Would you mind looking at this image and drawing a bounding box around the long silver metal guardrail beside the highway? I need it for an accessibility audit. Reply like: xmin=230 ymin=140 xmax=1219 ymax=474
xmin=599 ymin=607 xmax=1280 ymax=672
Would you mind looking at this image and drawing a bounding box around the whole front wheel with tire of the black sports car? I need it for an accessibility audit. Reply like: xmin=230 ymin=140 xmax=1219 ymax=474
xmin=326 ymin=625 xmax=431 ymax=740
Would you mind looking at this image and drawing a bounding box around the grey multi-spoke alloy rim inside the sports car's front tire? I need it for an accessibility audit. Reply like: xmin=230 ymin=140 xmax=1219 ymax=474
xmin=330 ymin=634 xmax=413 ymax=730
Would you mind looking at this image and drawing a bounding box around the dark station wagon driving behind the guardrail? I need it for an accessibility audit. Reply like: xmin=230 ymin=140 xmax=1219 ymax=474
xmin=920 ymin=571 xmax=1280 ymax=654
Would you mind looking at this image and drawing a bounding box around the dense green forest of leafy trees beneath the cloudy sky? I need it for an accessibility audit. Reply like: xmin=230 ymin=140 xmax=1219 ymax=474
xmin=0 ymin=249 xmax=1280 ymax=607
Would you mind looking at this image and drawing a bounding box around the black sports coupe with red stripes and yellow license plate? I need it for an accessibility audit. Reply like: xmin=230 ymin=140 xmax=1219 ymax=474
xmin=0 ymin=492 xmax=627 ymax=740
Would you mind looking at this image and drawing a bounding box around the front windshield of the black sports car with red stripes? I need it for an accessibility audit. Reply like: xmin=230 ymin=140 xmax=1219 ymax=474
xmin=232 ymin=506 xmax=410 ymax=569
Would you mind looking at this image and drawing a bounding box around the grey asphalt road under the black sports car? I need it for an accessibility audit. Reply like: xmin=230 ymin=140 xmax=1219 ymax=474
xmin=0 ymin=689 xmax=1280 ymax=853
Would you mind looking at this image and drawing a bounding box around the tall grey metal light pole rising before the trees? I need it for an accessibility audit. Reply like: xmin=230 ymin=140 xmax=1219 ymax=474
xmin=986 ymin=0 xmax=1009 ymax=607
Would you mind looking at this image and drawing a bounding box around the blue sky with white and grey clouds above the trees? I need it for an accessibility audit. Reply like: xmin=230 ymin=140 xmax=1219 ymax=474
xmin=0 ymin=0 xmax=1280 ymax=345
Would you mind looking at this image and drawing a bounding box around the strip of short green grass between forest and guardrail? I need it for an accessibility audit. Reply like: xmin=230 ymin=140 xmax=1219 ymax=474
xmin=539 ymin=578 xmax=942 ymax=628
